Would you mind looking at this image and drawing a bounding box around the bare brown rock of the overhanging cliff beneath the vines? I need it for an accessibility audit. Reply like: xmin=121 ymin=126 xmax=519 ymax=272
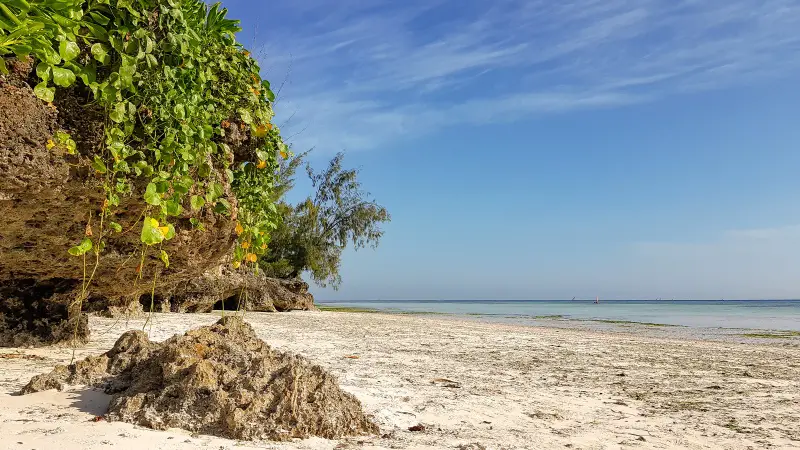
xmin=0 ymin=60 xmax=236 ymax=345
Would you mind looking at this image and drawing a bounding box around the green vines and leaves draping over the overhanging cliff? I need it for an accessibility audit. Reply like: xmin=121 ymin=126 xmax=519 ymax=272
xmin=0 ymin=0 xmax=288 ymax=265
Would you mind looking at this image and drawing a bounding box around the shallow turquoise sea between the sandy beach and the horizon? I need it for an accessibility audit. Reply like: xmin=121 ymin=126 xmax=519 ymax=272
xmin=320 ymin=300 xmax=800 ymax=331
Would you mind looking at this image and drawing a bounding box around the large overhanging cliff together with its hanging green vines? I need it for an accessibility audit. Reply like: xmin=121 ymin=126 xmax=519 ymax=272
xmin=0 ymin=0 xmax=290 ymax=344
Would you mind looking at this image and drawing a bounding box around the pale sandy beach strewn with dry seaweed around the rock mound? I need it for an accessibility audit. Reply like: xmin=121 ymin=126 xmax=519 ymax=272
xmin=0 ymin=312 xmax=800 ymax=450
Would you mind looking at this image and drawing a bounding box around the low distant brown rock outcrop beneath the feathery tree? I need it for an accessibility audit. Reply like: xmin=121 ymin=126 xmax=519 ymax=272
xmin=164 ymin=267 xmax=316 ymax=312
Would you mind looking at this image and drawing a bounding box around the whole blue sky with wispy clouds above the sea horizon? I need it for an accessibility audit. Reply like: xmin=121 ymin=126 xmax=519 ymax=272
xmin=225 ymin=0 xmax=800 ymax=301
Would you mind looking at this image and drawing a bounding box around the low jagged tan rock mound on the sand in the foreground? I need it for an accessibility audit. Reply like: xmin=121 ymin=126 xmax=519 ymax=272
xmin=22 ymin=316 xmax=378 ymax=441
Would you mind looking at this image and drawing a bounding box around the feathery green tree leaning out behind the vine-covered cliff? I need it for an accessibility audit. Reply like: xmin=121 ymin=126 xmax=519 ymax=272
xmin=261 ymin=152 xmax=391 ymax=289
